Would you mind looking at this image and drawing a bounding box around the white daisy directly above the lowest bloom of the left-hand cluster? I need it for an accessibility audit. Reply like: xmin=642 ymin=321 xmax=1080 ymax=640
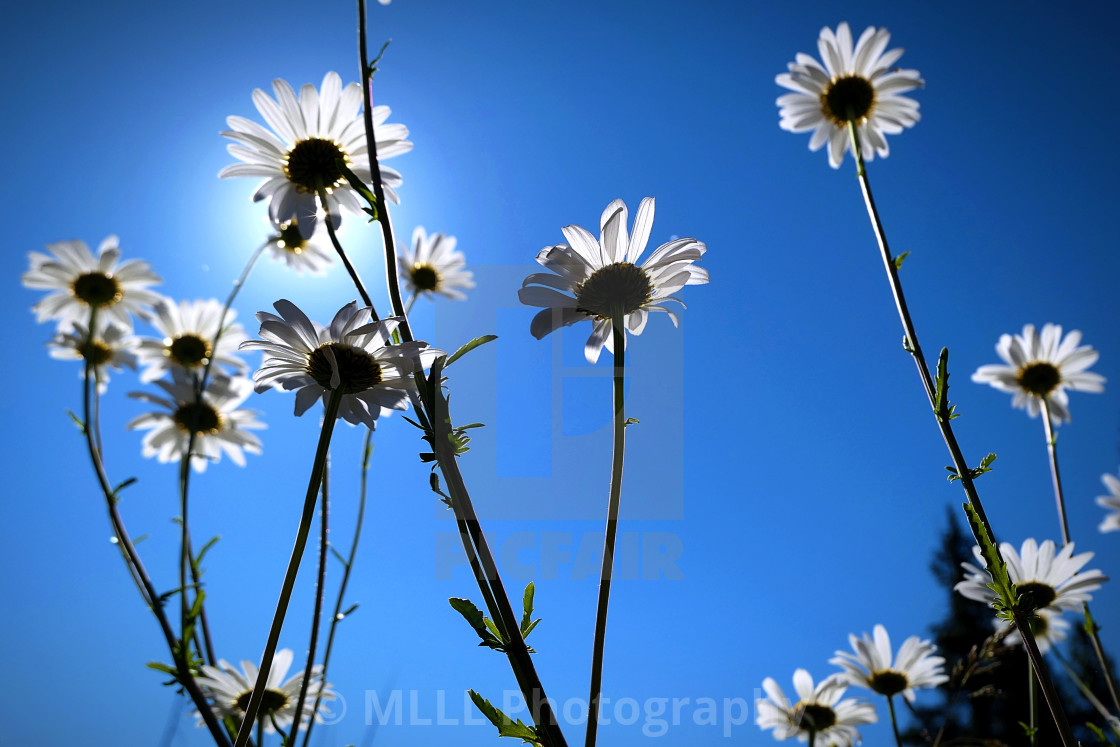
xmin=139 ymin=298 xmax=249 ymax=382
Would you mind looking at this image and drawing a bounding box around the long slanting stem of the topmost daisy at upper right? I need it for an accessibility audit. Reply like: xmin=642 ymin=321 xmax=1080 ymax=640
xmin=848 ymin=116 xmax=1076 ymax=747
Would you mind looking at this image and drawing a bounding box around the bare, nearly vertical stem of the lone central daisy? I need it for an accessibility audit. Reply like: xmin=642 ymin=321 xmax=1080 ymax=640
xmin=584 ymin=315 xmax=626 ymax=747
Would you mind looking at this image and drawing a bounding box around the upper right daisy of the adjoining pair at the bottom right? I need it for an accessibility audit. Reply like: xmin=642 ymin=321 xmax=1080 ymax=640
xmin=829 ymin=625 xmax=949 ymax=702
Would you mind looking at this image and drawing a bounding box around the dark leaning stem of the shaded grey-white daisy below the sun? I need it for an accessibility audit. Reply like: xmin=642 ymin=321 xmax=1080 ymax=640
xmin=234 ymin=389 xmax=343 ymax=747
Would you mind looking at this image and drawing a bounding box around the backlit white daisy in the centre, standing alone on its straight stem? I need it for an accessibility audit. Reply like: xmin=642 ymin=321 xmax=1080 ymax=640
xmin=517 ymin=197 xmax=708 ymax=363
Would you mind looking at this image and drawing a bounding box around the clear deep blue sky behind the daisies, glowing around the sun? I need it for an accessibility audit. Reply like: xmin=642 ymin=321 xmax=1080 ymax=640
xmin=0 ymin=0 xmax=1120 ymax=745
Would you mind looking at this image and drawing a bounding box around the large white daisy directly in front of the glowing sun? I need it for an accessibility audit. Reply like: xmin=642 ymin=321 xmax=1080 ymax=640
xmin=218 ymin=73 xmax=412 ymax=239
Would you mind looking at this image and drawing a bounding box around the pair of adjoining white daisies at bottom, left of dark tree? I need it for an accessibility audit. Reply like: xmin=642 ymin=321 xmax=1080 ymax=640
xmin=755 ymin=625 xmax=949 ymax=747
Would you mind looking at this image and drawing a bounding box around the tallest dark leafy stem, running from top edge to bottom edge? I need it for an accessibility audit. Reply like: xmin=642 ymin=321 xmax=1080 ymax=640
xmin=356 ymin=0 xmax=567 ymax=747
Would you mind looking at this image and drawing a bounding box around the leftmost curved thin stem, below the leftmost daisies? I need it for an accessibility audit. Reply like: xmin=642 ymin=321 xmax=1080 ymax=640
xmin=82 ymin=307 xmax=230 ymax=747
